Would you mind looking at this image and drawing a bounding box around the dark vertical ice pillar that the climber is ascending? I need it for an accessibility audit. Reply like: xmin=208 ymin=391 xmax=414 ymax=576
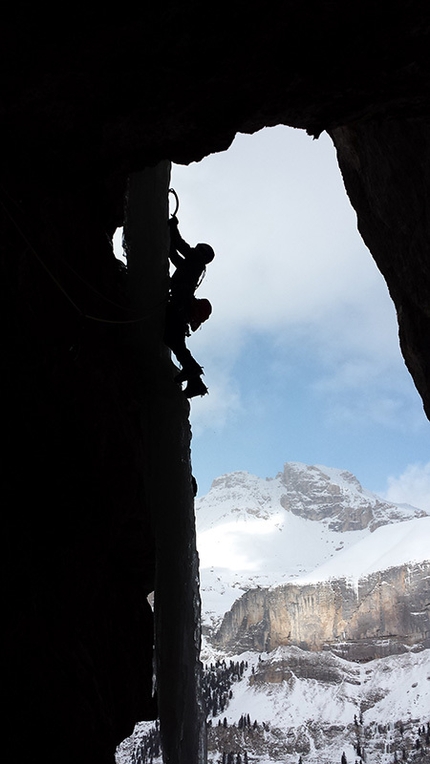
xmin=124 ymin=169 xmax=206 ymax=764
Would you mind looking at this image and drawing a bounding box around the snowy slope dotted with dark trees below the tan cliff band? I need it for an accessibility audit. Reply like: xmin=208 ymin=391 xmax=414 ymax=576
xmin=208 ymin=648 xmax=430 ymax=764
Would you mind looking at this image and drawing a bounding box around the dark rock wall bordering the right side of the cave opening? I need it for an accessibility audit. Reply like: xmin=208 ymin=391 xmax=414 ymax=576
xmin=331 ymin=117 xmax=430 ymax=419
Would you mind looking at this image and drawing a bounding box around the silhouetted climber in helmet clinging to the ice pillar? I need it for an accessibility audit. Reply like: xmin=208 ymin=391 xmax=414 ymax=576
xmin=164 ymin=215 xmax=215 ymax=398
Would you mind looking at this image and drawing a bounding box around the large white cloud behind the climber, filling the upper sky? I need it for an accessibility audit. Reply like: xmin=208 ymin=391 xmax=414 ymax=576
xmin=172 ymin=127 xmax=404 ymax=354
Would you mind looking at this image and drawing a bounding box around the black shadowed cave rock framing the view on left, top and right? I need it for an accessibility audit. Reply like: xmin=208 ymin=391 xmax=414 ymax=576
xmin=0 ymin=0 xmax=430 ymax=764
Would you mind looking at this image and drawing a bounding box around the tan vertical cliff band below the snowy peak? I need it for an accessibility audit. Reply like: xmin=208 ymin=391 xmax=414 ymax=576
xmin=214 ymin=563 xmax=430 ymax=660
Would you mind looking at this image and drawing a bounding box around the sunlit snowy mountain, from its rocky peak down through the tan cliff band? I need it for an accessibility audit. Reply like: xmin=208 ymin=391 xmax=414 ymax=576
xmin=197 ymin=463 xmax=430 ymax=660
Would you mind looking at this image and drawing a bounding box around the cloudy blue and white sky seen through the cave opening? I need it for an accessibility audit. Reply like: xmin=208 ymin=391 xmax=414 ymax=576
xmin=118 ymin=126 xmax=430 ymax=511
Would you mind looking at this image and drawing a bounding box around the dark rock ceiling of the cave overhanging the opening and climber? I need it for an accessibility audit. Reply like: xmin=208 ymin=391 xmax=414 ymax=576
xmin=1 ymin=0 xmax=430 ymax=175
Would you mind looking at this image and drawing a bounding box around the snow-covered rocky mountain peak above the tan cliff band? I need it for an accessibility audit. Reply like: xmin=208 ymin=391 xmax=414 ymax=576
xmin=196 ymin=462 xmax=430 ymax=626
